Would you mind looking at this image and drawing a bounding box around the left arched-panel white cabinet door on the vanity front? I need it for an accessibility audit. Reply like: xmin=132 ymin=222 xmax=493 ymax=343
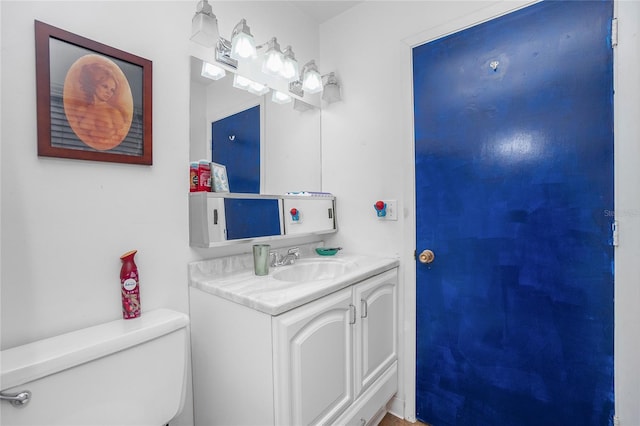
xmin=273 ymin=288 xmax=356 ymax=425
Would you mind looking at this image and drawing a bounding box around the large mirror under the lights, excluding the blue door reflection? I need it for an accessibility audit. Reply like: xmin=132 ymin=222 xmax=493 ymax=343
xmin=190 ymin=56 xmax=321 ymax=194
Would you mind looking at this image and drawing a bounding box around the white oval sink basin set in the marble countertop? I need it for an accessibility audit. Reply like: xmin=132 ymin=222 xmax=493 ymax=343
xmin=272 ymin=259 xmax=357 ymax=282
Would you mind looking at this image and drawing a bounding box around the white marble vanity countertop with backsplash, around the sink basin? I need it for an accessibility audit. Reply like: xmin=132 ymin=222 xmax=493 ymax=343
xmin=189 ymin=252 xmax=399 ymax=315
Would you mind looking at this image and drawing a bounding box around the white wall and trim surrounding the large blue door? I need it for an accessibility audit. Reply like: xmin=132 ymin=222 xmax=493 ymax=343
xmin=320 ymin=0 xmax=640 ymax=426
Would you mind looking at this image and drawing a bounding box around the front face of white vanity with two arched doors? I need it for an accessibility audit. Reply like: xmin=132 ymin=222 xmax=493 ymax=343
xmin=273 ymin=269 xmax=397 ymax=425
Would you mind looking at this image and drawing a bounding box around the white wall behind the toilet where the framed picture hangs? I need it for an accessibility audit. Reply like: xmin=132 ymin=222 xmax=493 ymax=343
xmin=1 ymin=1 xmax=192 ymax=348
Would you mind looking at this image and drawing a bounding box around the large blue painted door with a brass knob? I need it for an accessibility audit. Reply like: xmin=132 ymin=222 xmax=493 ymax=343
xmin=413 ymin=1 xmax=613 ymax=426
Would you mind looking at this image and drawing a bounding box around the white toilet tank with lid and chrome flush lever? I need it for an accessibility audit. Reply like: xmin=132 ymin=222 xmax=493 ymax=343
xmin=0 ymin=309 xmax=189 ymax=426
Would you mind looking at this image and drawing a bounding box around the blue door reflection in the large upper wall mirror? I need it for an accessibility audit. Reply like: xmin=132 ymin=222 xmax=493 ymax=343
xmin=211 ymin=106 xmax=260 ymax=194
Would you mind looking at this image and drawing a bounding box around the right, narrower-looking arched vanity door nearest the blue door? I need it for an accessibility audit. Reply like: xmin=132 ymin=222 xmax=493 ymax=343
xmin=353 ymin=269 xmax=398 ymax=396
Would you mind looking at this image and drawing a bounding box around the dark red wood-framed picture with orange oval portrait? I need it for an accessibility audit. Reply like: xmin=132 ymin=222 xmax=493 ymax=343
xmin=35 ymin=21 xmax=152 ymax=165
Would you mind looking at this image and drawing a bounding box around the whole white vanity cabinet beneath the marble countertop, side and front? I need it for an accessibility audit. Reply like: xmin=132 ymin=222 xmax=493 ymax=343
xmin=190 ymin=267 xmax=398 ymax=426
